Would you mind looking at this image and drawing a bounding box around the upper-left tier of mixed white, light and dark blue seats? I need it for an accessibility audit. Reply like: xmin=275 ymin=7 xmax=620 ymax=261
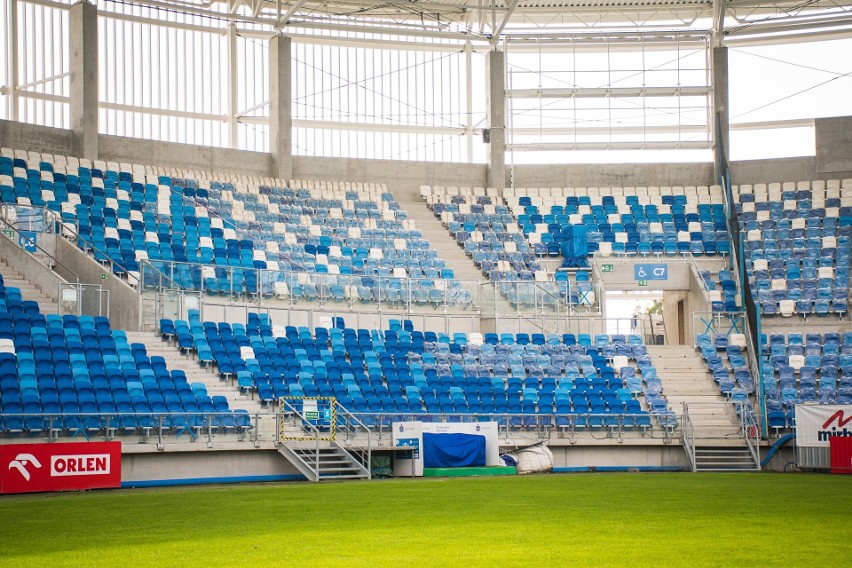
xmin=0 ymin=149 xmax=470 ymax=304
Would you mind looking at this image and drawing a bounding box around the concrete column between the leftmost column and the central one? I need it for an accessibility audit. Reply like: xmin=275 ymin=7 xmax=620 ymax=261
xmin=269 ymin=35 xmax=293 ymax=179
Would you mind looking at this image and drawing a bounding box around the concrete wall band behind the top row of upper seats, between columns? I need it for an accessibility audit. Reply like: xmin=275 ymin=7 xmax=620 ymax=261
xmin=0 ymin=117 xmax=852 ymax=193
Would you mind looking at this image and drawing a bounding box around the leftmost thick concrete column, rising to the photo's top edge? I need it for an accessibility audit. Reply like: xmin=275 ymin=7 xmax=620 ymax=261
xmin=69 ymin=2 xmax=98 ymax=160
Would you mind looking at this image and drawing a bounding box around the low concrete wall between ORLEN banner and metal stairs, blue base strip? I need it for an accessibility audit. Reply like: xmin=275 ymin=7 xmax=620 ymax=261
xmin=121 ymin=450 xmax=304 ymax=487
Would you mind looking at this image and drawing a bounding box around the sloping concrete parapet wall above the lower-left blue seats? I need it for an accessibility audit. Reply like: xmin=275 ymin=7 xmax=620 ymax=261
xmin=56 ymin=238 xmax=141 ymax=331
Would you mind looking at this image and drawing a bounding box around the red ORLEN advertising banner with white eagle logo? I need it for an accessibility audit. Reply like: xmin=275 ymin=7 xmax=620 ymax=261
xmin=0 ymin=442 xmax=121 ymax=493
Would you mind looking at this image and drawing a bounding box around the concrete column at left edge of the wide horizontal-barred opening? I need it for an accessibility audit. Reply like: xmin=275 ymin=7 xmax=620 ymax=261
xmin=485 ymin=50 xmax=506 ymax=190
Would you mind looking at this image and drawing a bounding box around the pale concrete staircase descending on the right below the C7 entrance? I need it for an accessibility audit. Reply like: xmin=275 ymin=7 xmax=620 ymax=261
xmin=648 ymin=345 xmax=758 ymax=471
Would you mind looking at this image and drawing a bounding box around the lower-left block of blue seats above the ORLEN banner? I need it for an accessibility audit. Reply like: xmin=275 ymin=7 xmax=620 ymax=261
xmin=0 ymin=270 xmax=250 ymax=438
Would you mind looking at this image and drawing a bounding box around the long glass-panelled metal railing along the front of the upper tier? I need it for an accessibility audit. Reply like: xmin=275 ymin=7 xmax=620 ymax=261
xmin=139 ymin=259 xmax=600 ymax=317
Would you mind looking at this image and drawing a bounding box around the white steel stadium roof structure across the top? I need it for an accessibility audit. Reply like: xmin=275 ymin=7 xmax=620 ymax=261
xmin=116 ymin=0 xmax=852 ymax=46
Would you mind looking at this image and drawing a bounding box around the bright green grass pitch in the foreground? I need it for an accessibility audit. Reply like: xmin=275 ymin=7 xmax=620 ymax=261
xmin=0 ymin=473 xmax=852 ymax=568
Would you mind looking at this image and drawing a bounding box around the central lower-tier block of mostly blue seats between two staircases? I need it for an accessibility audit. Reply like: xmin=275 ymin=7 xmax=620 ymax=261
xmin=161 ymin=312 xmax=673 ymax=427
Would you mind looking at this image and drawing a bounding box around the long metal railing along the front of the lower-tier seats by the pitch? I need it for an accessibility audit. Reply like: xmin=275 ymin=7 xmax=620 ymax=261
xmin=0 ymin=410 xmax=686 ymax=450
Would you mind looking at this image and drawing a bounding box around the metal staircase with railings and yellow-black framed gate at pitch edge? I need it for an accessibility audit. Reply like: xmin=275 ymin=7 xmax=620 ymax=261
xmin=278 ymin=398 xmax=371 ymax=481
